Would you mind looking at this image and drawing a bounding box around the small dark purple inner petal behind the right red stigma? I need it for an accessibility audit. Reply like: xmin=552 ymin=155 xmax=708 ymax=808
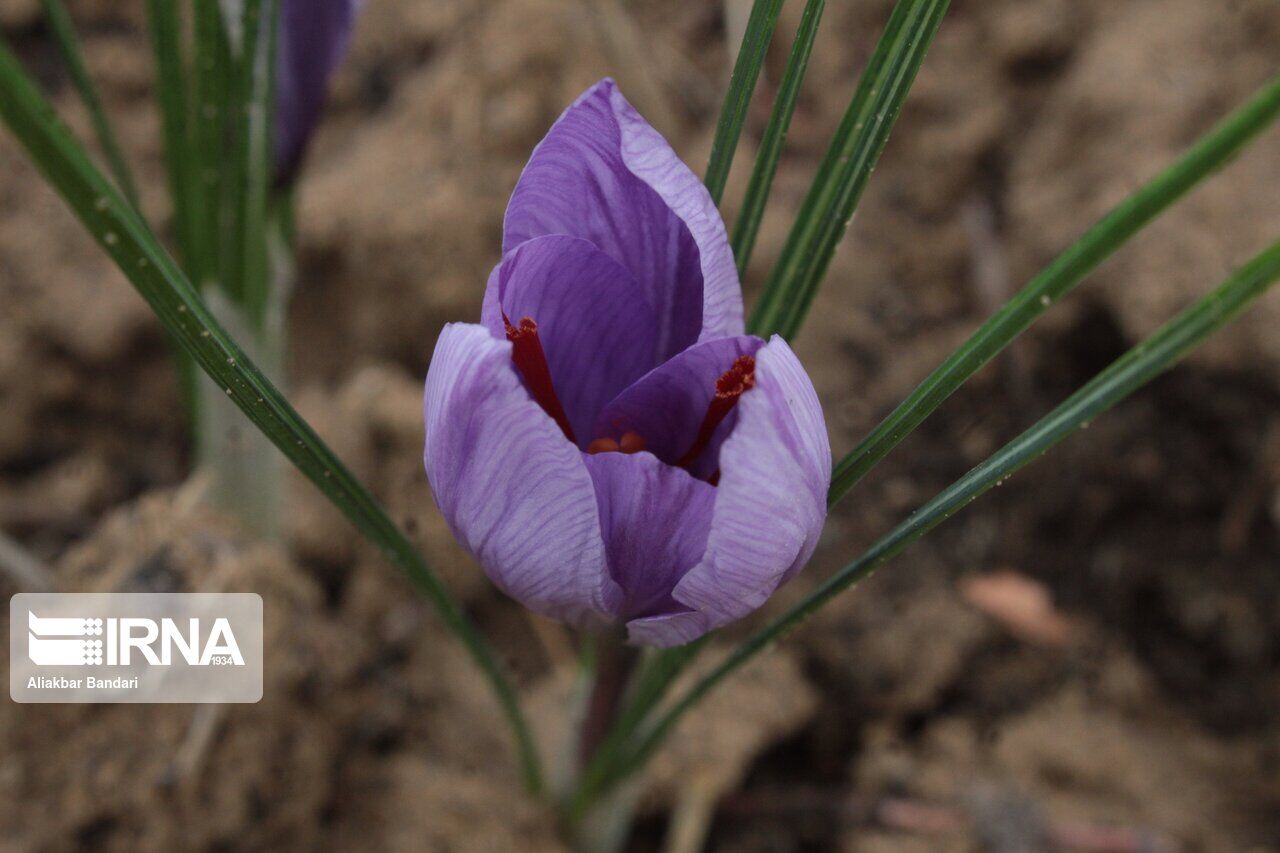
xmin=595 ymin=334 xmax=764 ymax=479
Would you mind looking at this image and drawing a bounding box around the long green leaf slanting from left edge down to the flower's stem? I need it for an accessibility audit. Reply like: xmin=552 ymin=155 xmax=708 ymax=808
xmin=0 ymin=38 xmax=541 ymax=792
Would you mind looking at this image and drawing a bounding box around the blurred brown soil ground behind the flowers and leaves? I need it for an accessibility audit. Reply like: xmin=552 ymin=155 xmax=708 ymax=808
xmin=0 ymin=0 xmax=1280 ymax=850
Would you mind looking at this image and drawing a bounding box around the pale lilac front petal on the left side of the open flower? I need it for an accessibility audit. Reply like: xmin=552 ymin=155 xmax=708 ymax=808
xmin=424 ymin=323 xmax=621 ymax=626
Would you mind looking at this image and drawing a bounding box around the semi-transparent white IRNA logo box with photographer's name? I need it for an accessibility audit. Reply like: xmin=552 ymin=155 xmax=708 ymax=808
xmin=9 ymin=593 xmax=262 ymax=703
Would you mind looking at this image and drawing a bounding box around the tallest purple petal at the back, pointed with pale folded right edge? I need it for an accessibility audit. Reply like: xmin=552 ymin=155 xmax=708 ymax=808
xmin=503 ymin=79 xmax=742 ymax=359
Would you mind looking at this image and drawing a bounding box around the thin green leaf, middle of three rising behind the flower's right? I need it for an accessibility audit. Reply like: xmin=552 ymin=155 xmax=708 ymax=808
xmin=730 ymin=0 xmax=827 ymax=275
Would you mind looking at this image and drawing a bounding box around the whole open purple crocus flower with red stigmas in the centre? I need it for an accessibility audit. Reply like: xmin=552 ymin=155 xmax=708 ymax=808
xmin=425 ymin=79 xmax=831 ymax=646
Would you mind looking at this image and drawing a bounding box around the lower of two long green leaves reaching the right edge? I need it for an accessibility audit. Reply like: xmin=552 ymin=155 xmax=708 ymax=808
xmin=586 ymin=235 xmax=1280 ymax=797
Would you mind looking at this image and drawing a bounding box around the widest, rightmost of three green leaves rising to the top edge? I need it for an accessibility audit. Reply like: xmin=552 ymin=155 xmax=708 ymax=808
xmin=748 ymin=0 xmax=948 ymax=339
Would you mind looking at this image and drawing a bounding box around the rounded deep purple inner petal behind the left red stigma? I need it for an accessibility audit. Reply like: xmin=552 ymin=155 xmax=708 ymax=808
xmin=481 ymin=236 xmax=657 ymax=447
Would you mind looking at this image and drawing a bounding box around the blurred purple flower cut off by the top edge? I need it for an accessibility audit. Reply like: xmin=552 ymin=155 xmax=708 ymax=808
xmin=275 ymin=0 xmax=360 ymax=183
